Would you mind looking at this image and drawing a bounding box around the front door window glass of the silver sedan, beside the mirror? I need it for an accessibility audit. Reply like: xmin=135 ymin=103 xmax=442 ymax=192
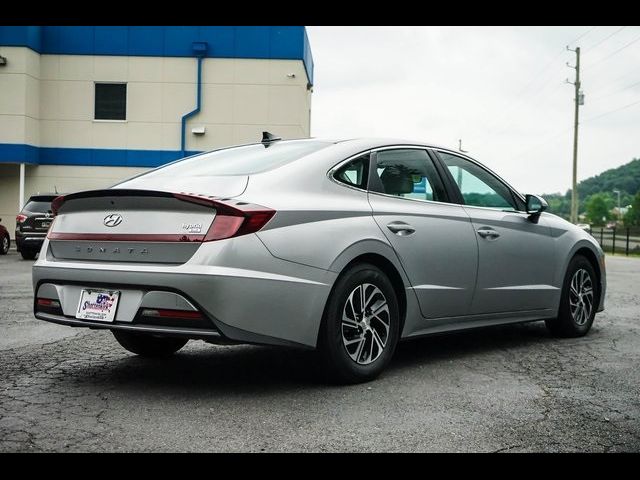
xmin=439 ymin=152 xmax=515 ymax=209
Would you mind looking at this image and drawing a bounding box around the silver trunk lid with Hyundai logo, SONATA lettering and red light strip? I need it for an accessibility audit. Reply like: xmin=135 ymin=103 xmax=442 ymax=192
xmin=48 ymin=188 xmax=275 ymax=264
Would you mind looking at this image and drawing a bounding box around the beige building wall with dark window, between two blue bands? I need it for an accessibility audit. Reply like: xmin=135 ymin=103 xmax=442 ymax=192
xmin=39 ymin=55 xmax=309 ymax=150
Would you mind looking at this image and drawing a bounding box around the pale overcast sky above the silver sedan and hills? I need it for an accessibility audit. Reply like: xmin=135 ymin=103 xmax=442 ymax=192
xmin=307 ymin=26 xmax=640 ymax=194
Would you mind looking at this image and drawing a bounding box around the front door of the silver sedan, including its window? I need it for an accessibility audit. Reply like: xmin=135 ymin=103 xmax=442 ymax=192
xmin=438 ymin=151 xmax=557 ymax=314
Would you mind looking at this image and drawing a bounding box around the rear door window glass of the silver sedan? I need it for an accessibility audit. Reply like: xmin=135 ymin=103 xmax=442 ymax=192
xmin=374 ymin=149 xmax=447 ymax=202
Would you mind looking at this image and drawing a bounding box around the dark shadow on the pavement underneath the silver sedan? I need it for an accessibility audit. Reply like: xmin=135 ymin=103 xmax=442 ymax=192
xmin=75 ymin=322 xmax=555 ymax=396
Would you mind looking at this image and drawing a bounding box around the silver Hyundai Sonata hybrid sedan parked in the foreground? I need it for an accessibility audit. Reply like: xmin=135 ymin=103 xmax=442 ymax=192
xmin=33 ymin=135 xmax=606 ymax=382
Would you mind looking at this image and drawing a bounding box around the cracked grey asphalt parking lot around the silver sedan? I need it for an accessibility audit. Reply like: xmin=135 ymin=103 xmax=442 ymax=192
xmin=0 ymin=251 xmax=640 ymax=452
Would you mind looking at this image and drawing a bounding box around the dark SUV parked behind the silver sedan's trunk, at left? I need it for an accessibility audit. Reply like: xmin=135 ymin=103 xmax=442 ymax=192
xmin=16 ymin=194 xmax=58 ymax=260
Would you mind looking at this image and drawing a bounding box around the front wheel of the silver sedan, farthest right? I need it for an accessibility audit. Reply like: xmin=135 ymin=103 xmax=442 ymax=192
xmin=545 ymin=255 xmax=600 ymax=337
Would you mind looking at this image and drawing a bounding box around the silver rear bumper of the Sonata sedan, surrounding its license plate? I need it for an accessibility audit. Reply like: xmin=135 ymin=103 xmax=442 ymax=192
xmin=33 ymin=235 xmax=336 ymax=348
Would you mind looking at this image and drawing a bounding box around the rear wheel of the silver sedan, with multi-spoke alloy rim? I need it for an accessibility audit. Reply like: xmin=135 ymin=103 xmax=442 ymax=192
xmin=318 ymin=264 xmax=400 ymax=383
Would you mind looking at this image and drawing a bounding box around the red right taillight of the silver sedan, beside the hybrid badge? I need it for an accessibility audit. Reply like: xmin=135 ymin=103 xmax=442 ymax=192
xmin=174 ymin=193 xmax=276 ymax=242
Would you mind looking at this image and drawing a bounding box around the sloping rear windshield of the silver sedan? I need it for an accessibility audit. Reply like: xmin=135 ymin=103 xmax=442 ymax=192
xmin=144 ymin=140 xmax=332 ymax=178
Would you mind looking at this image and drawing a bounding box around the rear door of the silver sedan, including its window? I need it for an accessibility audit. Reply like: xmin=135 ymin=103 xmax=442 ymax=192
xmin=369 ymin=147 xmax=478 ymax=318
